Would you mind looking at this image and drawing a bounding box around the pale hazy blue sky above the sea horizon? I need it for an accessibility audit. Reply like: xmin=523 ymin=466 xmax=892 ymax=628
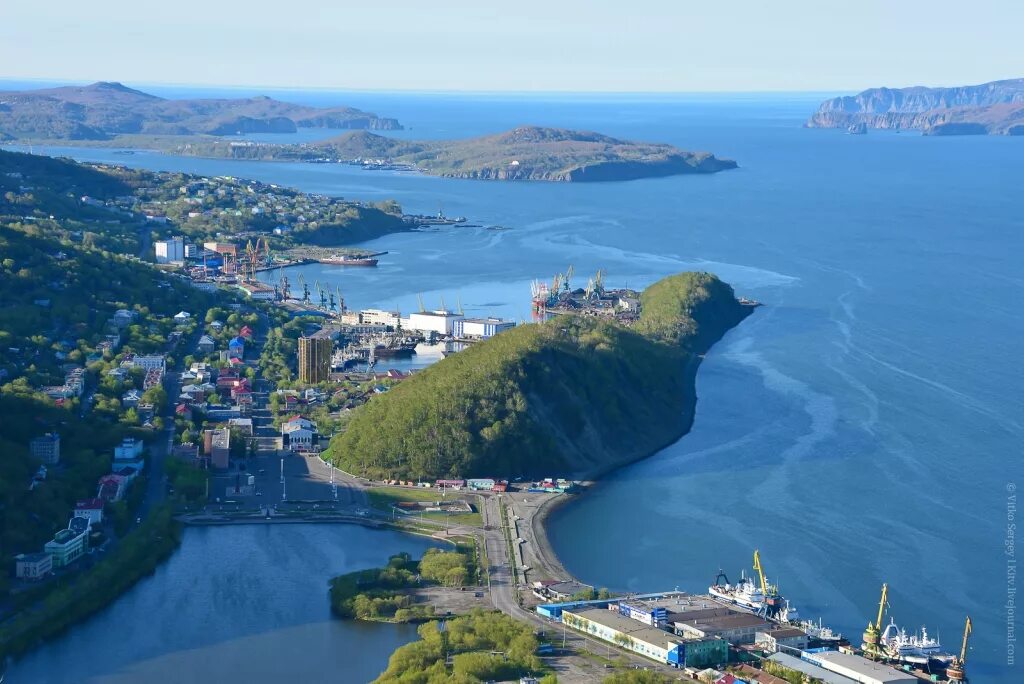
xmin=0 ymin=0 xmax=1024 ymax=91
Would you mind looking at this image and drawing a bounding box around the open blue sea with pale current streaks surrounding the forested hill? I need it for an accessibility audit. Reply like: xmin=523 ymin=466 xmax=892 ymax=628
xmin=9 ymin=87 xmax=1024 ymax=683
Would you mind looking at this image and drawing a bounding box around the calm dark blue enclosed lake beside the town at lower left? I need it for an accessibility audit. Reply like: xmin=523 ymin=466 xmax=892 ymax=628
xmin=4 ymin=524 xmax=433 ymax=684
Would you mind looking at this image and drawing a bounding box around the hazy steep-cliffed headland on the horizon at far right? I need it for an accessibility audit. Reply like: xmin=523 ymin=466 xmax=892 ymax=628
xmin=807 ymin=79 xmax=1024 ymax=135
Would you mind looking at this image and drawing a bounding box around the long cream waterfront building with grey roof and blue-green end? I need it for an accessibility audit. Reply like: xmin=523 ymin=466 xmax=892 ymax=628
xmin=562 ymin=606 xmax=729 ymax=668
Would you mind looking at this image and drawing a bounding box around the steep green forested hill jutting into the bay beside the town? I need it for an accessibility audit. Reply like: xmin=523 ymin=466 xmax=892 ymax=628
xmin=327 ymin=272 xmax=752 ymax=479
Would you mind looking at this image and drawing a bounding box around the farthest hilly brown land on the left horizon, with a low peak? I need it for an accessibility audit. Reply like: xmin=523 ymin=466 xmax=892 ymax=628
xmin=0 ymin=82 xmax=401 ymax=141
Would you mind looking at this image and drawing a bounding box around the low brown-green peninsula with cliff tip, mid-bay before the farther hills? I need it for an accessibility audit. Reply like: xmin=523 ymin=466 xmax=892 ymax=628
xmin=142 ymin=126 xmax=737 ymax=182
